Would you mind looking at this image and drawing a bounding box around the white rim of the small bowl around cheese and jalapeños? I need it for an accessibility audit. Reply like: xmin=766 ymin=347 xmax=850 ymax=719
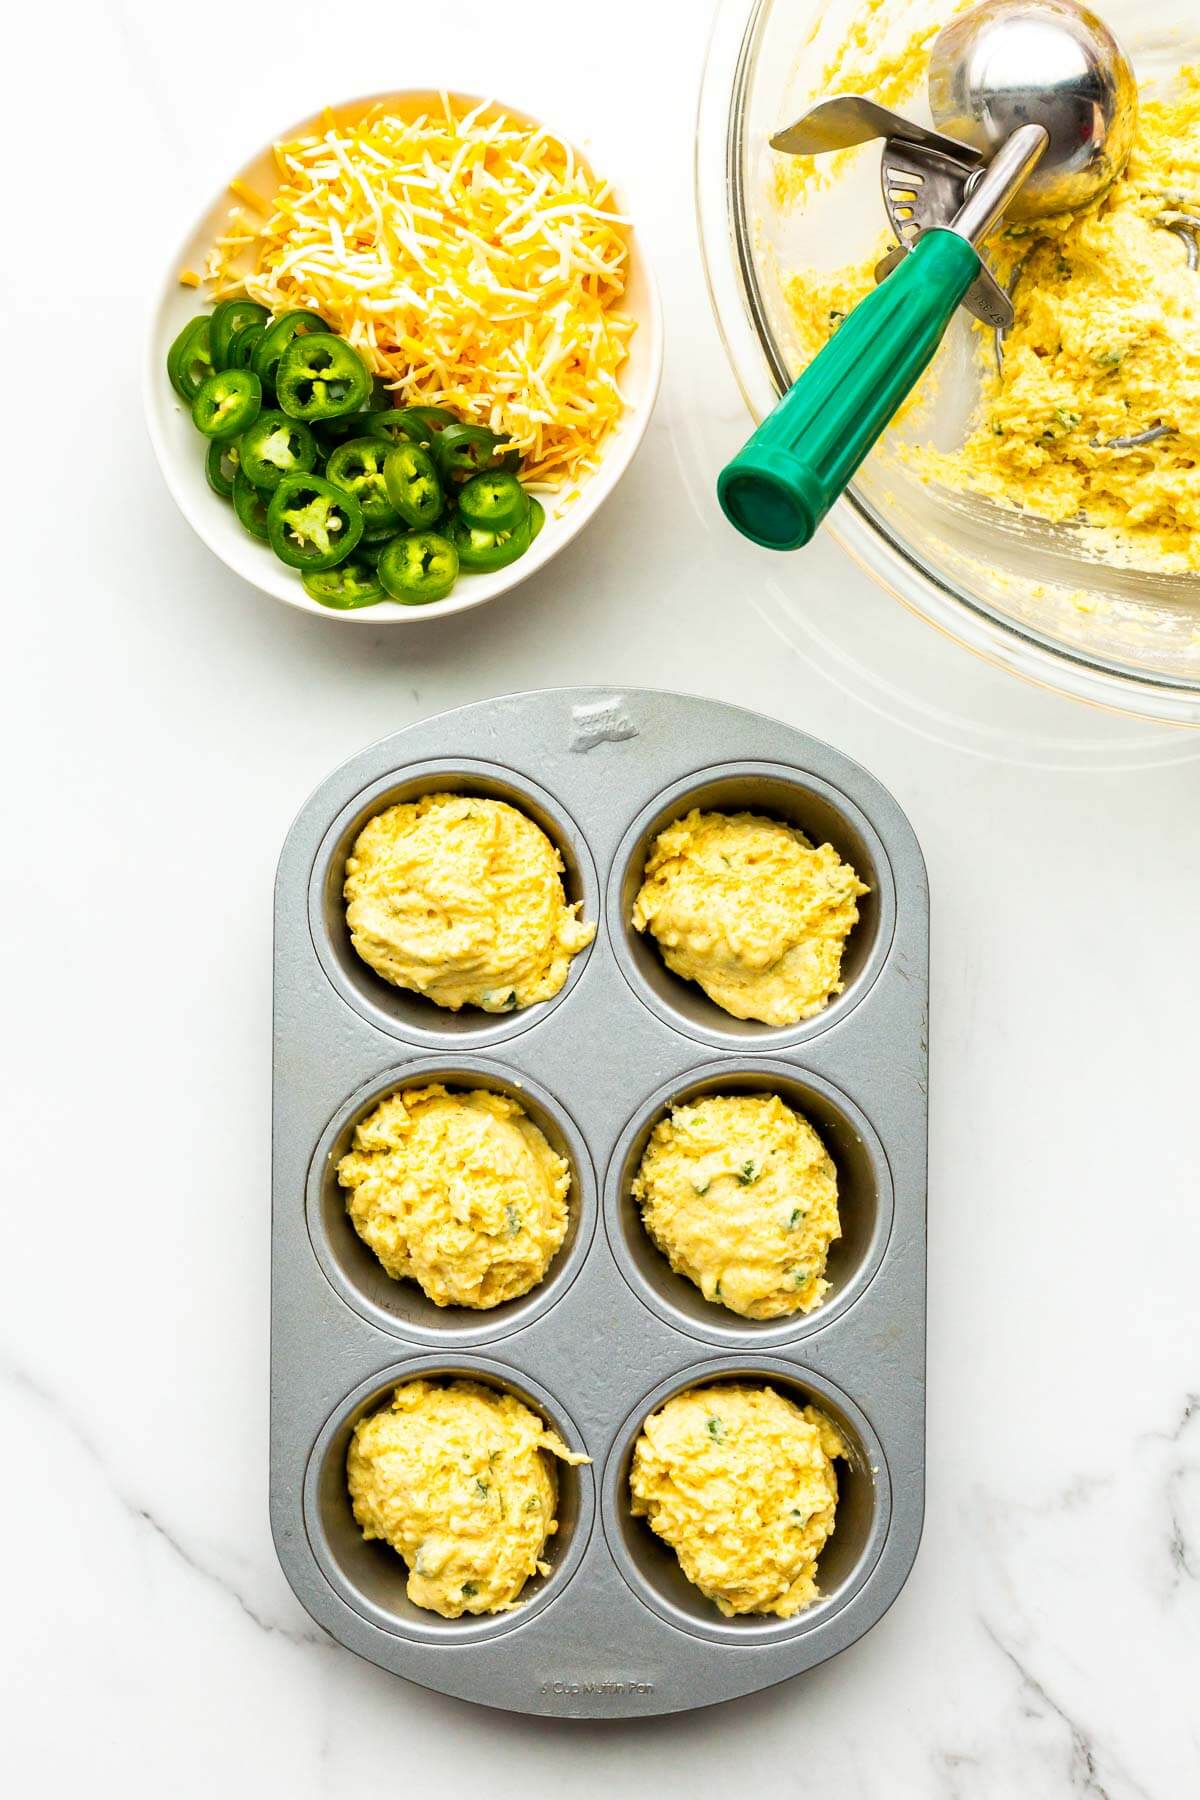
xmin=142 ymin=83 xmax=664 ymax=626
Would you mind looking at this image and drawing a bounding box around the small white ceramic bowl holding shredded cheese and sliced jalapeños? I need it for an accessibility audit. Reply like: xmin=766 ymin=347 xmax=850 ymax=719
xmin=144 ymin=90 xmax=662 ymax=625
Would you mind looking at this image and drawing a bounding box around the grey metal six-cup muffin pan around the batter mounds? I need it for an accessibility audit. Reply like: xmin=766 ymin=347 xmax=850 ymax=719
xmin=272 ymin=689 xmax=928 ymax=1719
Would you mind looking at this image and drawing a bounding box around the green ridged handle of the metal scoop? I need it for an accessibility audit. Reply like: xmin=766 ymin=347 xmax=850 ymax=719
xmin=716 ymin=229 xmax=981 ymax=551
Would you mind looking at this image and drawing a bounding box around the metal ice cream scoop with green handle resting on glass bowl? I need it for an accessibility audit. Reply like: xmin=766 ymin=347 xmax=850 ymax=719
xmin=718 ymin=0 xmax=1137 ymax=549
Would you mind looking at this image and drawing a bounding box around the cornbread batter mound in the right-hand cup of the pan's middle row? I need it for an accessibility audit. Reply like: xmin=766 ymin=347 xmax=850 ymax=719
xmin=631 ymin=1094 xmax=842 ymax=1319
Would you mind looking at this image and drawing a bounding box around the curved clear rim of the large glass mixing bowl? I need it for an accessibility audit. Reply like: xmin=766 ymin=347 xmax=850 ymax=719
xmin=694 ymin=0 xmax=1200 ymax=727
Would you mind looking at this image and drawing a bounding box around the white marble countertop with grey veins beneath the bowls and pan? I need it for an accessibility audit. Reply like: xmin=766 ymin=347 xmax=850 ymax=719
xmin=0 ymin=0 xmax=1200 ymax=1800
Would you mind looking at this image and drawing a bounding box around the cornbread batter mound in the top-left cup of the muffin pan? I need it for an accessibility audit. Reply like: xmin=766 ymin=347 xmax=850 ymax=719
xmin=345 ymin=794 xmax=596 ymax=1013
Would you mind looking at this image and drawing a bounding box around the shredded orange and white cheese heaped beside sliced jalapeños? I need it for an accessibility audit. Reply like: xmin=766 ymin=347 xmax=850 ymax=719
xmin=205 ymin=95 xmax=635 ymax=488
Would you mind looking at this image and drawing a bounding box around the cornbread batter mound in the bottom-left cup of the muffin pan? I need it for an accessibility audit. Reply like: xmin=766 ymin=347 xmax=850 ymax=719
xmin=345 ymin=1381 xmax=588 ymax=1618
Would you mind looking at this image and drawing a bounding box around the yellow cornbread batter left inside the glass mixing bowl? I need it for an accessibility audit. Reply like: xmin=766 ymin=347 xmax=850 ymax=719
xmin=916 ymin=70 xmax=1200 ymax=571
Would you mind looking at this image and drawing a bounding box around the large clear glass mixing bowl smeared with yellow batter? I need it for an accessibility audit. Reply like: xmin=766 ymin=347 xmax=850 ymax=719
xmin=696 ymin=0 xmax=1200 ymax=725
